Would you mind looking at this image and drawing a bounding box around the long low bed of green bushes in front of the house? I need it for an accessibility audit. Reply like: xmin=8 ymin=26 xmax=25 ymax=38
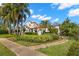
xmin=16 ymin=34 xmax=59 ymax=43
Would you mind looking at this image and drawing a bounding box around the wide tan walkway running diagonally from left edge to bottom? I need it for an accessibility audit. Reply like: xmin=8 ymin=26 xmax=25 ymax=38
xmin=0 ymin=38 xmax=45 ymax=56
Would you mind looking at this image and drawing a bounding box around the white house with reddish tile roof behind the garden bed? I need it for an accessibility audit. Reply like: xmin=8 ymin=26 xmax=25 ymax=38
xmin=25 ymin=22 xmax=49 ymax=35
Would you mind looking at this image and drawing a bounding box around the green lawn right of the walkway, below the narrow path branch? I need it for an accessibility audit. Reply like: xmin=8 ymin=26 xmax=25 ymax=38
xmin=39 ymin=40 xmax=75 ymax=56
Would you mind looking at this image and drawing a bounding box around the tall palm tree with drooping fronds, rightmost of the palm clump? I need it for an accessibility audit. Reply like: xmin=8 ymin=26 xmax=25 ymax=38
xmin=13 ymin=3 xmax=30 ymax=34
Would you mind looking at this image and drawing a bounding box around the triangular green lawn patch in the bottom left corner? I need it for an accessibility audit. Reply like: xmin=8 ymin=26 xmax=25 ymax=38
xmin=0 ymin=43 xmax=15 ymax=56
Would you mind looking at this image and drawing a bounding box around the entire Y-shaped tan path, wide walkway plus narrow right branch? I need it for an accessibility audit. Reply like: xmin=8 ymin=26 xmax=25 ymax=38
xmin=0 ymin=38 xmax=68 ymax=56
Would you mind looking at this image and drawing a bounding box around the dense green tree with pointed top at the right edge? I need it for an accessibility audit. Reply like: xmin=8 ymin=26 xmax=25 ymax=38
xmin=60 ymin=18 xmax=79 ymax=37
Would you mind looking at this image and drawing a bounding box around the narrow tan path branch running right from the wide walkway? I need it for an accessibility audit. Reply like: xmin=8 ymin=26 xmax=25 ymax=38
xmin=29 ymin=39 xmax=68 ymax=50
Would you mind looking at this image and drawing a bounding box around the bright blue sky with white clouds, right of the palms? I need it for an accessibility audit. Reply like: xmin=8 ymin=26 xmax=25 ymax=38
xmin=26 ymin=3 xmax=79 ymax=23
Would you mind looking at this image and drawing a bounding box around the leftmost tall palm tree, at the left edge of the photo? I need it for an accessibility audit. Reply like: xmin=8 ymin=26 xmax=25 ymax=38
xmin=0 ymin=4 xmax=10 ymax=33
